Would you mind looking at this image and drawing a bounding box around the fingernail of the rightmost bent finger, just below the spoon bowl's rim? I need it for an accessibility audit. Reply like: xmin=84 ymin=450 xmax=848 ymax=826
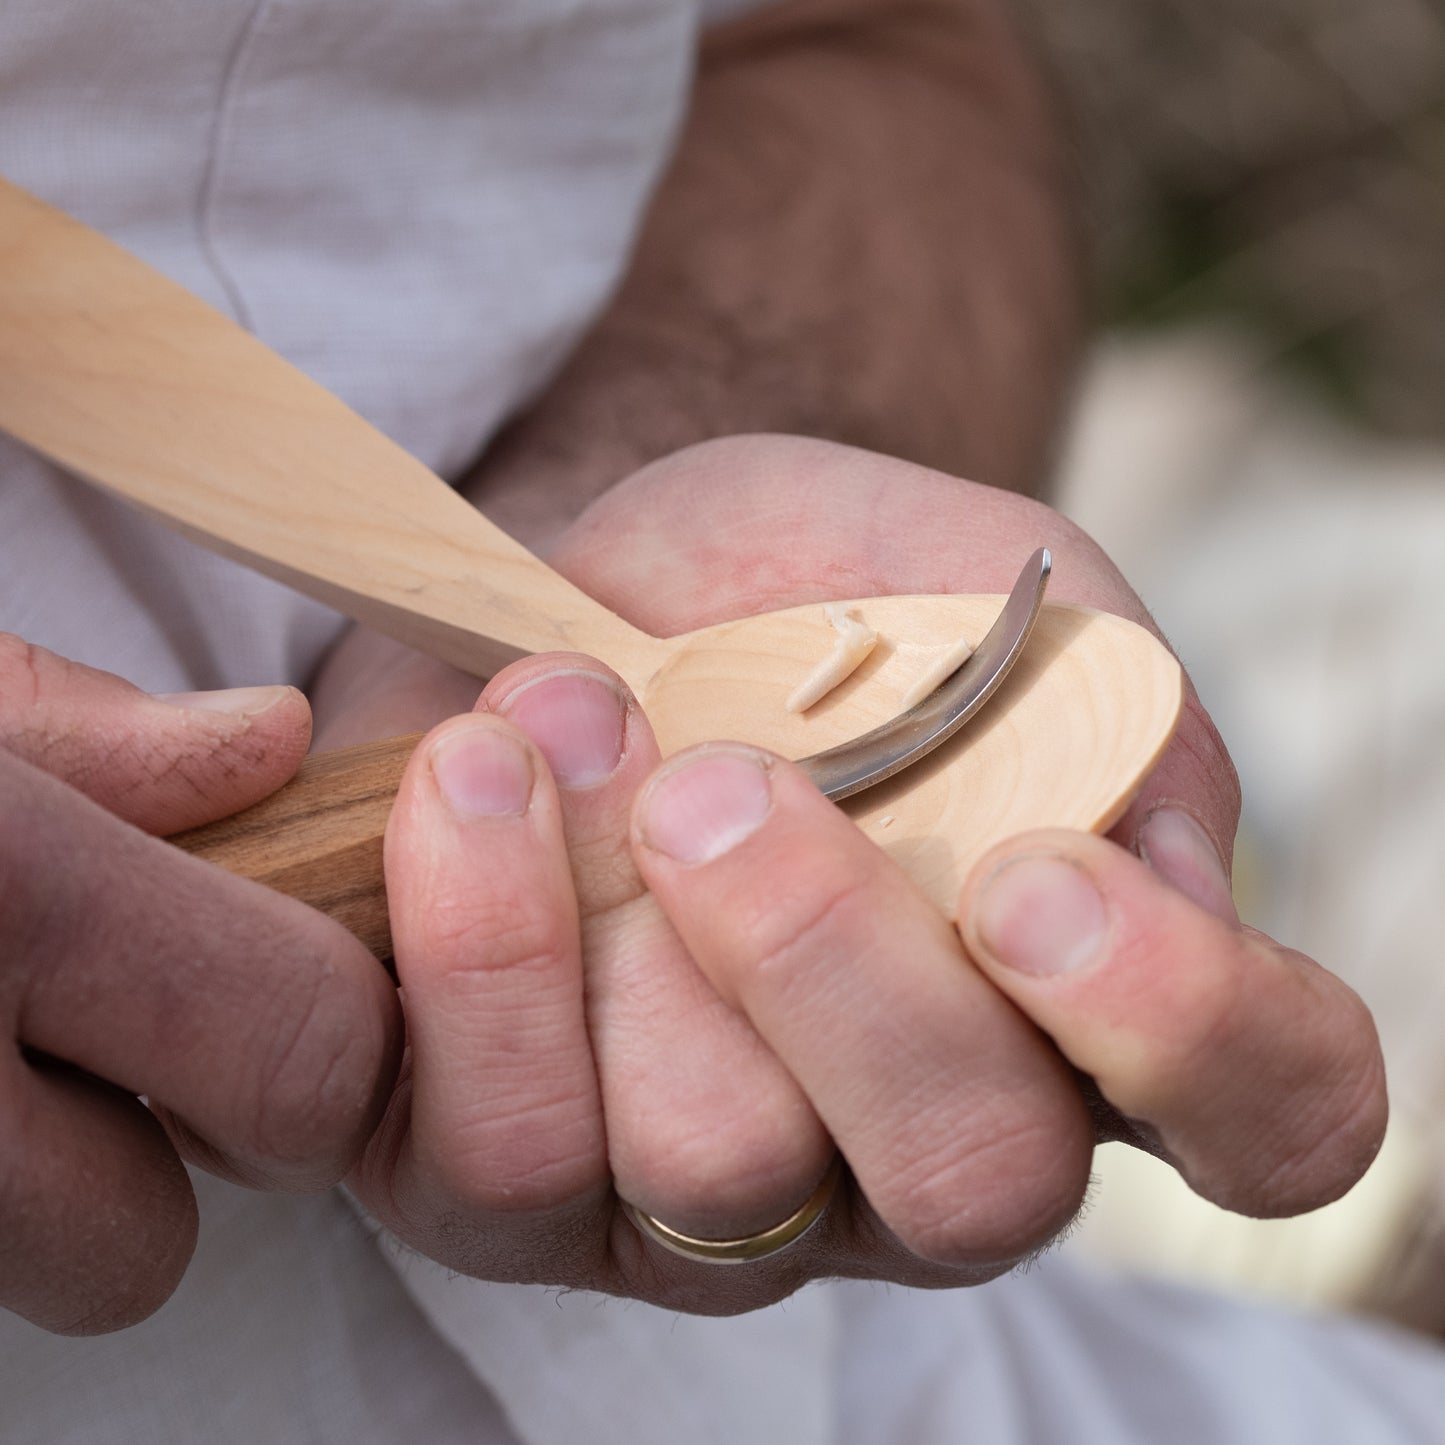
xmin=970 ymin=854 xmax=1108 ymax=978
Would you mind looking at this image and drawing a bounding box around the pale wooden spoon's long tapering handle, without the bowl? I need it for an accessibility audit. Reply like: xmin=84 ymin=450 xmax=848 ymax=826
xmin=0 ymin=179 xmax=659 ymax=681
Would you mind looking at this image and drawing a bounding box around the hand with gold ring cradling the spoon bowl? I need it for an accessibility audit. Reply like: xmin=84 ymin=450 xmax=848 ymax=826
xmin=330 ymin=438 xmax=1384 ymax=1311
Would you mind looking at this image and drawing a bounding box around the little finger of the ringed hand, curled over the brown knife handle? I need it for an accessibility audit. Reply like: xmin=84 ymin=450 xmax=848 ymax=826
xmin=372 ymin=715 xmax=607 ymax=1279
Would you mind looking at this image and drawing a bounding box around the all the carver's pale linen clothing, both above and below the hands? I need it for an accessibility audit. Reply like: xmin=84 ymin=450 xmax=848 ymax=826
xmin=0 ymin=0 xmax=1445 ymax=1445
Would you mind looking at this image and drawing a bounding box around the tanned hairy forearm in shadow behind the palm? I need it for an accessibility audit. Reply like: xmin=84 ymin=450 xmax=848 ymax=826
xmin=468 ymin=0 xmax=1082 ymax=545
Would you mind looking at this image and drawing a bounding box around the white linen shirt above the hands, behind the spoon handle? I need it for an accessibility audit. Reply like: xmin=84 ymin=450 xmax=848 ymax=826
xmin=0 ymin=0 xmax=710 ymax=689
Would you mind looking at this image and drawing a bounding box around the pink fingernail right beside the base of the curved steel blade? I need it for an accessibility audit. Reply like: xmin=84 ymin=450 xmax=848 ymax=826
xmin=639 ymin=747 xmax=773 ymax=863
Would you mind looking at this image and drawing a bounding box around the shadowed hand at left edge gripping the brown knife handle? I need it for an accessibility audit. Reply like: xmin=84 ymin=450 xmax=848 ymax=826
xmin=0 ymin=634 xmax=400 ymax=1334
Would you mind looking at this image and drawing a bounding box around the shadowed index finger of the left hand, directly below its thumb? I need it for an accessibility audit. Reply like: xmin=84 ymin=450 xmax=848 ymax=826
xmin=0 ymin=754 xmax=399 ymax=1188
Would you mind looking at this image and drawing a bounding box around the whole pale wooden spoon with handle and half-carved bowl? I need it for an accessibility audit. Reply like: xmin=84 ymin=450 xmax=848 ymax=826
xmin=0 ymin=181 xmax=1182 ymax=942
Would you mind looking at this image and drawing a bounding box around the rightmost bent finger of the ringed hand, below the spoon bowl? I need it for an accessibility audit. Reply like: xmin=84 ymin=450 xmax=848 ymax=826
xmin=959 ymin=832 xmax=1386 ymax=1215
